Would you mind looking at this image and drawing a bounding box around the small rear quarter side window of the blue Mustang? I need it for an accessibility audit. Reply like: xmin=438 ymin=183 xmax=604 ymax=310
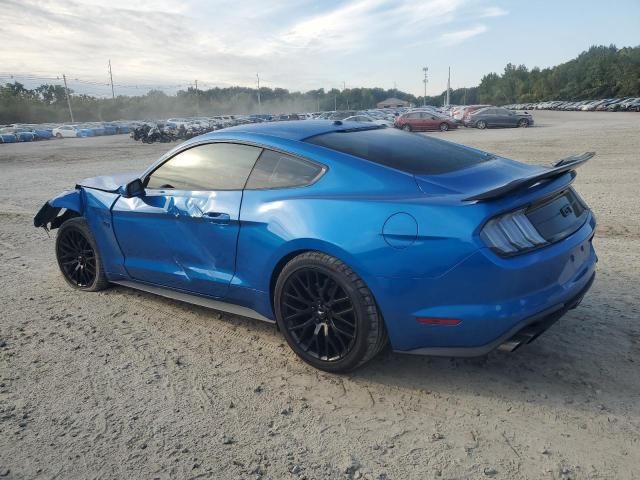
xmin=246 ymin=150 xmax=322 ymax=189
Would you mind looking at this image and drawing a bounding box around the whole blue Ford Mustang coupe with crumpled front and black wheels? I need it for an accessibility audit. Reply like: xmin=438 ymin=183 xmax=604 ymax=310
xmin=34 ymin=120 xmax=596 ymax=372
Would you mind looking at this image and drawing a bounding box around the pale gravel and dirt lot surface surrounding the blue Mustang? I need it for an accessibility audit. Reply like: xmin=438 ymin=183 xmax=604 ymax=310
xmin=0 ymin=112 xmax=640 ymax=480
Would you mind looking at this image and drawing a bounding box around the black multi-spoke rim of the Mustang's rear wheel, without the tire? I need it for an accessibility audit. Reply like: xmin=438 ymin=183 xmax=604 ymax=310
xmin=280 ymin=268 xmax=357 ymax=361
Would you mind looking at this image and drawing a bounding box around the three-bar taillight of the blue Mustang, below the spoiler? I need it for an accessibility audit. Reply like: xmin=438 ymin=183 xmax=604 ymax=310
xmin=480 ymin=210 xmax=549 ymax=255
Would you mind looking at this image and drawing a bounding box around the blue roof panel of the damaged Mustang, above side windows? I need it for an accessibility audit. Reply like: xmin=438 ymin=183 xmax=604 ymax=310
xmin=200 ymin=120 xmax=384 ymax=141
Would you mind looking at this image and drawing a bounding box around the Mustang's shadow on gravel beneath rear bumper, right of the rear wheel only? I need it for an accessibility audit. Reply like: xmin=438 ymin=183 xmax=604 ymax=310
xmin=350 ymin=315 xmax=640 ymax=415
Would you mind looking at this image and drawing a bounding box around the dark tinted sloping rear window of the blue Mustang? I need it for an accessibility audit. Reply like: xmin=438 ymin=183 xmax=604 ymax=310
xmin=306 ymin=128 xmax=494 ymax=175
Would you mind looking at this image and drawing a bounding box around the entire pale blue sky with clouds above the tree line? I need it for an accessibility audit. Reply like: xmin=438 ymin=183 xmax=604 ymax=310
xmin=0 ymin=0 xmax=640 ymax=96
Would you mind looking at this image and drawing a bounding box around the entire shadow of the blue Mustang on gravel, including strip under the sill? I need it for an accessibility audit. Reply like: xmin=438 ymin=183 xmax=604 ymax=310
xmin=108 ymin=286 xmax=640 ymax=414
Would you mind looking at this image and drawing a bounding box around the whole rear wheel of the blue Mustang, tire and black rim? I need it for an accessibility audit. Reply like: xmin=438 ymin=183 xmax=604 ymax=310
xmin=274 ymin=252 xmax=387 ymax=373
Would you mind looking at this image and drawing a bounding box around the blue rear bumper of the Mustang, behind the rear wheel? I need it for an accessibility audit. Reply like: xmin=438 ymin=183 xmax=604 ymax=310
xmin=367 ymin=213 xmax=597 ymax=356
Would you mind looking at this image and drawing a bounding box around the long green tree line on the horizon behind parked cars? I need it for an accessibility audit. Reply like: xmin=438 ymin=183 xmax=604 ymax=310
xmin=0 ymin=45 xmax=640 ymax=124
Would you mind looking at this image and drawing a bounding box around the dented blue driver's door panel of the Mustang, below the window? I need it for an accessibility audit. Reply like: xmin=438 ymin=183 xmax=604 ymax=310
xmin=112 ymin=189 xmax=242 ymax=297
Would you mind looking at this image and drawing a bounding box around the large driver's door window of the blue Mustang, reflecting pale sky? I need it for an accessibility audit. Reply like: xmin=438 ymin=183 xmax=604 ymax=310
xmin=146 ymin=143 xmax=262 ymax=190
